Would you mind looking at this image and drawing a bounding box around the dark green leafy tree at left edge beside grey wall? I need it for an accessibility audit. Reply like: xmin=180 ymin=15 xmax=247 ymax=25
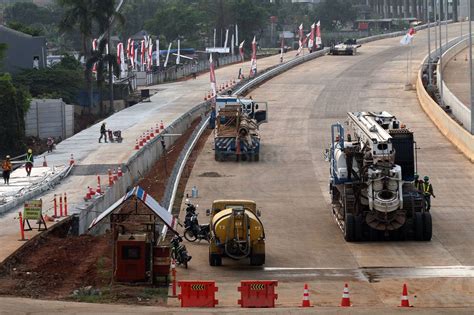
xmin=0 ymin=73 xmax=30 ymax=156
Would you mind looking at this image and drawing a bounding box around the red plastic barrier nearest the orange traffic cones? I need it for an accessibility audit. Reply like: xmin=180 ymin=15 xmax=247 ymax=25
xmin=237 ymin=280 xmax=278 ymax=307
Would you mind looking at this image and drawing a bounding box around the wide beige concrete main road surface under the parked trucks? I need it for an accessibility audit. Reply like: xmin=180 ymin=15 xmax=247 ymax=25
xmin=177 ymin=21 xmax=474 ymax=308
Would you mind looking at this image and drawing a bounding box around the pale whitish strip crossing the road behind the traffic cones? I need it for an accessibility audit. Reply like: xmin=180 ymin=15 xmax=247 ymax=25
xmin=218 ymin=266 xmax=474 ymax=283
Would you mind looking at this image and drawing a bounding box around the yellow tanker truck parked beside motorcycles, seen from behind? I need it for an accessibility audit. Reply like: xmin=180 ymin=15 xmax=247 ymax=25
xmin=207 ymin=200 xmax=265 ymax=266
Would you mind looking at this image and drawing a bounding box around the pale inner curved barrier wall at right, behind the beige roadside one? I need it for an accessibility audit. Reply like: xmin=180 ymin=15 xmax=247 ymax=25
xmin=436 ymin=36 xmax=471 ymax=130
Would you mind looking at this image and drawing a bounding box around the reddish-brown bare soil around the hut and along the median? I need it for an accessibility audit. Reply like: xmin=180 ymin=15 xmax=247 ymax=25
xmin=0 ymin=118 xmax=211 ymax=305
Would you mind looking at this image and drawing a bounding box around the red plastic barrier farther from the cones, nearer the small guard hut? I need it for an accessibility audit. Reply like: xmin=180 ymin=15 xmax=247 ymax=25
xmin=178 ymin=280 xmax=218 ymax=307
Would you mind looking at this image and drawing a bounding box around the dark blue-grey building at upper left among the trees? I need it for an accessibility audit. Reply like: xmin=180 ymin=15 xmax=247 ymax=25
xmin=0 ymin=25 xmax=46 ymax=73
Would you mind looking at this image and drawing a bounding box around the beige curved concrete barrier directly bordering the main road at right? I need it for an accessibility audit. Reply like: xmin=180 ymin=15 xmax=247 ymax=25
xmin=416 ymin=65 xmax=474 ymax=162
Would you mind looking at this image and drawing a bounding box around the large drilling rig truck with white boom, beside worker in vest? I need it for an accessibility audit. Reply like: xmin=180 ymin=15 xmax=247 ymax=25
xmin=326 ymin=112 xmax=432 ymax=242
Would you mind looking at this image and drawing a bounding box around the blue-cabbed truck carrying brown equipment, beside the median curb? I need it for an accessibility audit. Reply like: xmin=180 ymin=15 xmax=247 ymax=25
xmin=211 ymin=96 xmax=268 ymax=161
